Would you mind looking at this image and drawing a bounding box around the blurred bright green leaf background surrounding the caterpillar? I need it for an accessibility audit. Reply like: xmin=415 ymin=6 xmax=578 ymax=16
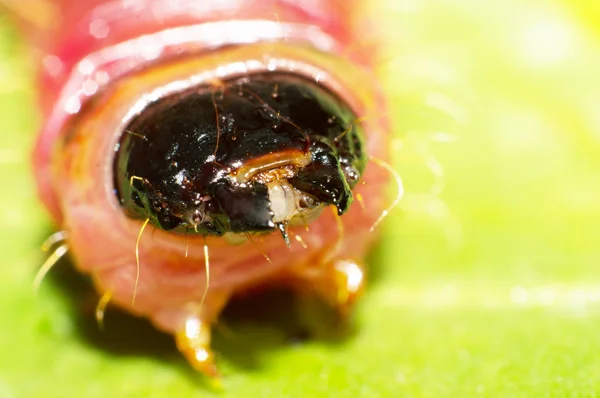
xmin=0 ymin=0 xmax=600 ymax=398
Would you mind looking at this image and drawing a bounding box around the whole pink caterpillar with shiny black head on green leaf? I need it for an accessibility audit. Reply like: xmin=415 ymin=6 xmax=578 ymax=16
xmin=7 ymin=0 xmax=401 ymax=377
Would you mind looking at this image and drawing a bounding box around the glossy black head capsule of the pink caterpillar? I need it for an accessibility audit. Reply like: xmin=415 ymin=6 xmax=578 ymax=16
xmin=114 ymin=73 xmax=366 ymax=237
